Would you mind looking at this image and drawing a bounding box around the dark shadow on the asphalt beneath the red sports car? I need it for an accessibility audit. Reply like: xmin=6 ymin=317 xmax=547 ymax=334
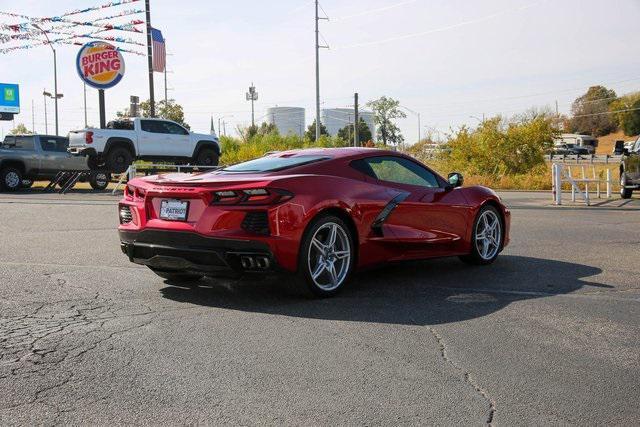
xmin=161 ymin=255 xmax=613 ymax=325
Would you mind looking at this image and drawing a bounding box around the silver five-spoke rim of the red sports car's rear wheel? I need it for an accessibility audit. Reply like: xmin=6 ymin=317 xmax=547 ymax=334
xmin=307 ymin=222 xmax=351 ymax=291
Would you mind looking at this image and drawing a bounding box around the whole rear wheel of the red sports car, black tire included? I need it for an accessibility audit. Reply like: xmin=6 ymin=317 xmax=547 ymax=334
xmin=295 ymin=215 xmax=357 ymax=298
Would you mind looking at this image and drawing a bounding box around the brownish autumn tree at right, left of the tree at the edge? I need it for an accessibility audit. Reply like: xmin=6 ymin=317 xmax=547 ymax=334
xmin=570 ymin=86 xmax=616 ymax=136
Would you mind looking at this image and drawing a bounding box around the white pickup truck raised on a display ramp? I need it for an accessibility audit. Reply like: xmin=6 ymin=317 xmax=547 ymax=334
xmin=69 ymin=118 xmax=220 ymax=173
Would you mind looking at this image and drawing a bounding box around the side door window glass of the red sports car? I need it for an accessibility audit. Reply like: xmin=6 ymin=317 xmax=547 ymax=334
xmin=363 ymin=156 xmax=440 ymax=188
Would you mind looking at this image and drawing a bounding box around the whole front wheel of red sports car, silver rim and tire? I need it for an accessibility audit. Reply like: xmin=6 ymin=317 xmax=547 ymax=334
xmin=460 ymin=205 xmax=503 ymax=265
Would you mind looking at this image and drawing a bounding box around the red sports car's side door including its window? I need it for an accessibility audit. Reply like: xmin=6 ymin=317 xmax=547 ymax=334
xmin=361 ymin=156 xmax=468 ymax=258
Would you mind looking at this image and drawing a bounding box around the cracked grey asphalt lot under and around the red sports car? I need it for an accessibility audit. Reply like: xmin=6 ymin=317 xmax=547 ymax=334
xmin=0 ymin=193 xmax=640 ymax=425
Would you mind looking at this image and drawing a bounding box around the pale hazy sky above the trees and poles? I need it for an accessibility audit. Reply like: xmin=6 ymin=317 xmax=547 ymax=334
xmin=0 ymin=0 xmax=640 ymax=143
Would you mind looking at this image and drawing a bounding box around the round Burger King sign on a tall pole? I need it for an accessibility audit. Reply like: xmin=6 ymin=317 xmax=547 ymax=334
xmin=76 ymin=41 xmax=124 ymax=89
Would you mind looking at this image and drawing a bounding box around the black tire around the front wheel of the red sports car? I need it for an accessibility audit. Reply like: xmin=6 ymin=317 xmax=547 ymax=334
xmin=460 ymin=205 xmax=504 ymax=265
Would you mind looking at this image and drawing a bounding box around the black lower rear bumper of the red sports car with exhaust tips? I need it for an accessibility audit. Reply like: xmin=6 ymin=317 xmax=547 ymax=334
xmin=118 ymin=229 xmax=279 ymax=275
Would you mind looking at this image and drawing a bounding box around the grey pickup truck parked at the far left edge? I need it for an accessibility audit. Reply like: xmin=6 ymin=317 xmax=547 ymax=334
xmin=0 ymin=135 xmax=109 ymax=191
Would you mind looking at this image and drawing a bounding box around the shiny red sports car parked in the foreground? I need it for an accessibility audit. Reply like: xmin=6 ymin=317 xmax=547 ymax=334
xmin=119 ymin=148 xmax=510 ymax=296
